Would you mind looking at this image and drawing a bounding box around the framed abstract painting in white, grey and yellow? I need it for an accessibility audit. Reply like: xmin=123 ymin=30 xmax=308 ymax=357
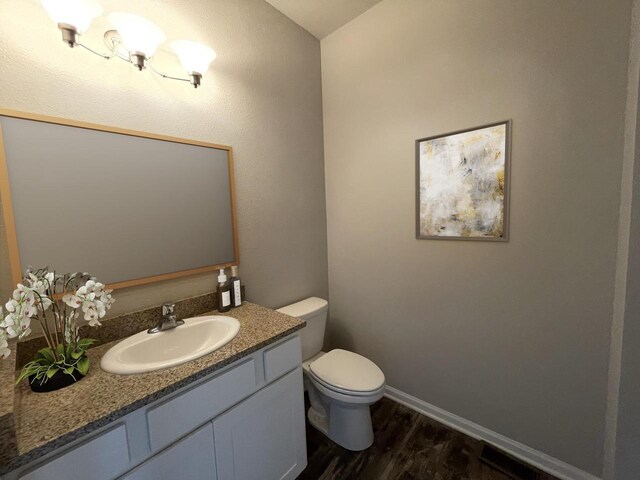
xmin=416 ymin=120 xmax=511 ymax=242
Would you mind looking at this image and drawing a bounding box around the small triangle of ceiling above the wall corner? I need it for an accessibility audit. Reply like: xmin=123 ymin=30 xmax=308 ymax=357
xmin=267 ymin=0 xmax=381 ymax=40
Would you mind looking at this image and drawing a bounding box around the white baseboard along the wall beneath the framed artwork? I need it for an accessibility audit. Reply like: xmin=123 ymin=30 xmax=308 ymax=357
xmin=385 ymin=385 xmax=601 ymax=480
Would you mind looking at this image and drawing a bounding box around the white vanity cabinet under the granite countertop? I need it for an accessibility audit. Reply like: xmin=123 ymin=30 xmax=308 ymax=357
xmin=10 ymin=334 xmax=307 ymax=480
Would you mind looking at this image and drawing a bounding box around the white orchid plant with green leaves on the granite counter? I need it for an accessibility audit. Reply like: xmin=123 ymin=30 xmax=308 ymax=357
xmin=0 ymin=268 xmax=115 ymax=384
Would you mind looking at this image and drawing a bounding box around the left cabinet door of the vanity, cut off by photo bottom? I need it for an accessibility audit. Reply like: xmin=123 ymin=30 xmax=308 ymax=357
xmin=121 ymin=422 xmax=217 ymax=480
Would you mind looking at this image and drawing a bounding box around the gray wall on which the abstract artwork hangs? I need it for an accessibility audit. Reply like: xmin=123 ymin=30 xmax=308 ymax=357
xmin=322 ymin=0 xmax=631 ymax=475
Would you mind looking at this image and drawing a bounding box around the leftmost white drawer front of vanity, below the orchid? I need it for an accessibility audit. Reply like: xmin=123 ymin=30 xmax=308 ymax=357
xmin=20 ymin=424 xmax=130 ymax=480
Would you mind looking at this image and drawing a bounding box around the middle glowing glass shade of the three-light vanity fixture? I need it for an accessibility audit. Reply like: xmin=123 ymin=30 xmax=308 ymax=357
xmin=109 ymin=12 xmax=167 ymax=58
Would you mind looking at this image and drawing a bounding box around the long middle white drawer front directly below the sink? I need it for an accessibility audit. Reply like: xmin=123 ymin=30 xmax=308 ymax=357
xmin=147 ymin=360 xmax=256 ymax=451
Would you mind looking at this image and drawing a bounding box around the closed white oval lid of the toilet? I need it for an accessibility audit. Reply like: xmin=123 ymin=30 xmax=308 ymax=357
xmin=309 ymin=349 xmax=384 ymax=392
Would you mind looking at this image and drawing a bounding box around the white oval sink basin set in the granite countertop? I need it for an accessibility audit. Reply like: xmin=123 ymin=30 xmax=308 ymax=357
xmin=100 ymin=315 xmax=240 ymax=375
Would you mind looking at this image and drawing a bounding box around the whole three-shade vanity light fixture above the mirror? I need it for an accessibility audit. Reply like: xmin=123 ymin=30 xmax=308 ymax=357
xmin=41 ymin=0 xmax=216 ymax=88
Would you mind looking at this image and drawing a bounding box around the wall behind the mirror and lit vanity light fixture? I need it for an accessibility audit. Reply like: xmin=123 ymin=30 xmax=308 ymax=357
xmin=0 ymin=0 xmax=327 ymax=314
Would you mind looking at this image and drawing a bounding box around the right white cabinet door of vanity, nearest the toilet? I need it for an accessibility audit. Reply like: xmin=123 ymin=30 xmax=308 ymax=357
xmin=213 ymin=367 xmax=307 ymax=480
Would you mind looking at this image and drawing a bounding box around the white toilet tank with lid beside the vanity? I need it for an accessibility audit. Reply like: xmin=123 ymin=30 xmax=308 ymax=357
xmin=277 ymin=297 xmax=329 ymax=360
